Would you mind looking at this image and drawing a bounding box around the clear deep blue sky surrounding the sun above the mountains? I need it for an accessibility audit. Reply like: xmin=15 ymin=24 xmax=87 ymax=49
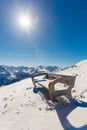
xmin=0 ymin=0 xmax=87 ymax=67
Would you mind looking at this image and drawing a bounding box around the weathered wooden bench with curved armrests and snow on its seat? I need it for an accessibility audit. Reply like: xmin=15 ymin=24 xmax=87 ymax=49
xmin=32 ymin=73 xmax=76 ymax=101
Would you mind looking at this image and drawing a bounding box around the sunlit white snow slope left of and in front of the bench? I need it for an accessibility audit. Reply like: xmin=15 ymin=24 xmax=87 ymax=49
xmin=0 ymin=79 xmax=59 ymax=130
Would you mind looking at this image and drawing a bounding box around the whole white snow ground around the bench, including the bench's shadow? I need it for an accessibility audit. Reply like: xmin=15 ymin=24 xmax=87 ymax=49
xmin=0 ymin=60 xmax=87 ymax=130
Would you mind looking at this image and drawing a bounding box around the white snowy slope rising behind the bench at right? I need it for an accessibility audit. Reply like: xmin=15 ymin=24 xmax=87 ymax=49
xmin=58 ymin=60 xmax=87 ymax=100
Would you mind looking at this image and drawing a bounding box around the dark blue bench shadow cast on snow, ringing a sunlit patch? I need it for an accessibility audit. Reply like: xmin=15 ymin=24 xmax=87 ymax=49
xmin=56 ymin=100 xmax=87 ymax=130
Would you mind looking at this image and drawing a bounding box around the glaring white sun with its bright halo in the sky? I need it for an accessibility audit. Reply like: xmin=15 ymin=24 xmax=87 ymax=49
xmin=15 ymin=11 xmax=39 ymax=32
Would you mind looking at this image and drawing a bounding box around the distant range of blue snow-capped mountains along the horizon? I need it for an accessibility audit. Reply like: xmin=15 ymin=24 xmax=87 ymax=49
xmin=0 ymin=65 xmax=61 ymax=86
